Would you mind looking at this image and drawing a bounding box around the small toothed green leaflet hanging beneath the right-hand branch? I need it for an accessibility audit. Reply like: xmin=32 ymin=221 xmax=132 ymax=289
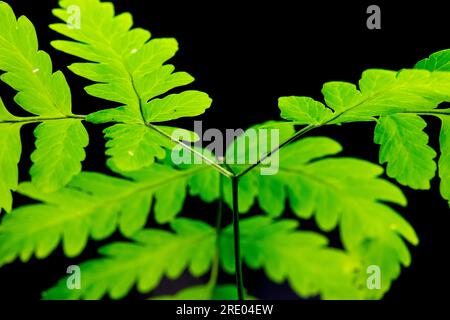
xmin=374 ymin=114 xmax=436 ymax=190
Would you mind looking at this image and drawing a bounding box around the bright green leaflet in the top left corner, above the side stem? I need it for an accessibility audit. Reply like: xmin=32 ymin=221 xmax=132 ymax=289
xmin=0 ymin=2 xmax=71 ymax=116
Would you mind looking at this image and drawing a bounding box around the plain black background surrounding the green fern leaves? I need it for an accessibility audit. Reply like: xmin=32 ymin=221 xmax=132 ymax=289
xmin=0 ymin=0 xmax=450 ymax=300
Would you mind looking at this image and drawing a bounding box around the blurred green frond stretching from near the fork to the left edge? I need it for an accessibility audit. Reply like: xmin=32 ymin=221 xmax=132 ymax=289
xmin=0 ymin=164 xmax=219 ymax=265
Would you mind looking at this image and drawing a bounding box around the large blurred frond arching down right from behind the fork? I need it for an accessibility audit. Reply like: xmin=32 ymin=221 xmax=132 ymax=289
xmin=224 ymin=125 xmax=418 ymax=292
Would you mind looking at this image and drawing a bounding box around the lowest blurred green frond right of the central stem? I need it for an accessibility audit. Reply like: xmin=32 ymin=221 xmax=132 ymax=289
xmin=220 ymin=217 xmax=359 ymax=299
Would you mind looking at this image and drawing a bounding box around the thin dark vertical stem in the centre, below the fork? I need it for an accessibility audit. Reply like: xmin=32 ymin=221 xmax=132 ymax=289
xmin=231 ymin=177 xmax=245 ymax=301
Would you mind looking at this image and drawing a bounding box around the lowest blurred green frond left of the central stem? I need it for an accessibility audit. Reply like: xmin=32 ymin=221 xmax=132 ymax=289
xmin=44 ymin=219 xmax=216 ymax=299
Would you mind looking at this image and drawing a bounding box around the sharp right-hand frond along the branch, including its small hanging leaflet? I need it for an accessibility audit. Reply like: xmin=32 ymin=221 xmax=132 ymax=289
xmin=279 ymin=63 xmax=450 ymax=189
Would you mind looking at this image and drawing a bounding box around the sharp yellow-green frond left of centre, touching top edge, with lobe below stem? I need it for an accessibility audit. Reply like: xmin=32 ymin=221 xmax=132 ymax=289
xmin=51 ymin=0 xmax=211 ymax=171
